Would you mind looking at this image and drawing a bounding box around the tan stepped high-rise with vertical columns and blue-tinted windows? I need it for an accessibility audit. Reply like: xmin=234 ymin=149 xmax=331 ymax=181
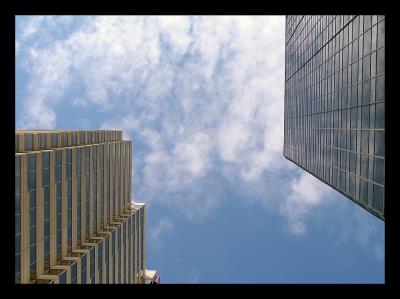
xmin=15 ymin=130 xmax=157 ymax=284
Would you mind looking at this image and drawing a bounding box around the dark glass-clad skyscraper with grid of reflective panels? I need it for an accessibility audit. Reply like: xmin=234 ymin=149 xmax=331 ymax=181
xmin=283 ymin=15 xmax=385 ymax=220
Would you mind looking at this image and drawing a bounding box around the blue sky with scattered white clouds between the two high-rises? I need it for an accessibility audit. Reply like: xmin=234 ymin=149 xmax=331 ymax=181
xmin=16 ymin=16 xmax=384 ymax=283
